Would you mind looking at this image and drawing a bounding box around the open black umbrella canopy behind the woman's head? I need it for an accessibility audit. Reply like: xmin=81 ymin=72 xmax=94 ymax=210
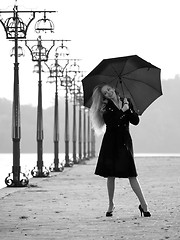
xmin=82 ymin=55 xmax=162 ymax=115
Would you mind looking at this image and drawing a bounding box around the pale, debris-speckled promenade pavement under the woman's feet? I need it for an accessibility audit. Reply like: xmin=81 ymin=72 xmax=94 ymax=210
xmin=0 ymin=157 xmax=180 ymax=240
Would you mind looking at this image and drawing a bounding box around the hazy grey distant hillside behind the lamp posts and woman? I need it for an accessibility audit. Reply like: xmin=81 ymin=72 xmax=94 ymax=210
xmin=0 ymin=75 xmax=180 ymax=153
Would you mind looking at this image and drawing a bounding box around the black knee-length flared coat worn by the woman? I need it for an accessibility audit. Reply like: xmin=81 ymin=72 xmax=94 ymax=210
xmin=95 ymin=100 xmax=139 ymax=178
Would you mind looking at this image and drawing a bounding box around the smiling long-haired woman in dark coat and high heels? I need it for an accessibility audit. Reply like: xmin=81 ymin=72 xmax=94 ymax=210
xmin=90 ymin=84 xmax=151 ymax=217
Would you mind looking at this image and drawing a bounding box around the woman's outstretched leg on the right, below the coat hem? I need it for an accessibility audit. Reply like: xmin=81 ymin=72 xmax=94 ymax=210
xmin=129 ymin=177 xmax=147 ymax=212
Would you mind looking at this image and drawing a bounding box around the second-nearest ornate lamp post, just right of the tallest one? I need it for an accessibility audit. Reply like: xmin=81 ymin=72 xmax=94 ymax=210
xmin=25 ymin=36 xmax=55 ymax=177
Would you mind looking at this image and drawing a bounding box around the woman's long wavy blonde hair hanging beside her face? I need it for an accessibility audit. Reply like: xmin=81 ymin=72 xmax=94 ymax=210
xmin=90 ymin=84 xmax=106 ymax=134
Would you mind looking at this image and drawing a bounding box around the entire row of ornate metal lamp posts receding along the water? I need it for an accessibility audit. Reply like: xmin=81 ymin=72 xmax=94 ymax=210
xmin=0 ymin=4 xmax=95 ymax=187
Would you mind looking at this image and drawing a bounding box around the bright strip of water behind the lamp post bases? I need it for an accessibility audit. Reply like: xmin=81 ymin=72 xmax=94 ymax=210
xmin=0 ymin=153 xmax=68 ymax=189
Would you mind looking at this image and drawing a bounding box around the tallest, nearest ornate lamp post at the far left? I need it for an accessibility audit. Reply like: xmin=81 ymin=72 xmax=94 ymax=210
xmin=0 ymin=4 xmax=55 ymax=187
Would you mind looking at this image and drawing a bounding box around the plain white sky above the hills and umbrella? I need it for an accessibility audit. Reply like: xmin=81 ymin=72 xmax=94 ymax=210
xmin=0 ymin=0 xmax=180 ymax=108
